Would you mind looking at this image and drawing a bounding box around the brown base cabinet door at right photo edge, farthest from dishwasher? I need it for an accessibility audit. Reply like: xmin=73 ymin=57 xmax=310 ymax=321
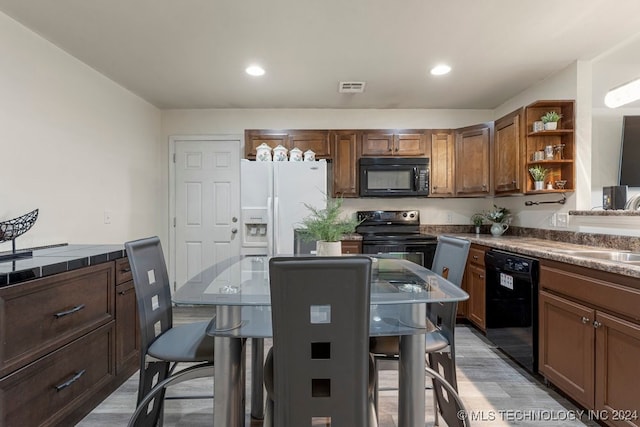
xmin=595 ymin=311 xmax=640 ymax=426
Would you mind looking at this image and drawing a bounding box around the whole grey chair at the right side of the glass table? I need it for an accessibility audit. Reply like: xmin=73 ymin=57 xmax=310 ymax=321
xmin=370 ymin=236 xmax=471 ymax=425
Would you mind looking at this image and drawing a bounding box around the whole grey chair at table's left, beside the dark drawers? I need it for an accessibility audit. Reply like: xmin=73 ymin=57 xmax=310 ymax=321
xmin=125 ymin=237 xmax=214 ymax=427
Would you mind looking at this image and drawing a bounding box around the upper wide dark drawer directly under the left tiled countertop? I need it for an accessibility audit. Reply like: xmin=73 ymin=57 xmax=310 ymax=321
xmin=0 ymin=262 xmax=115 ymax=376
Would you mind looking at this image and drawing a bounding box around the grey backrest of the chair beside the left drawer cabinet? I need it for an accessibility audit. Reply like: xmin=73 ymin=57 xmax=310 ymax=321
xmin=124 ymin=237 xmax=173 ymax=358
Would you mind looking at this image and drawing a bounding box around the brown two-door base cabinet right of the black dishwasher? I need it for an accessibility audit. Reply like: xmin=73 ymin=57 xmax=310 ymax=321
xmin=539 ymin=261 xmax=640 ymax=426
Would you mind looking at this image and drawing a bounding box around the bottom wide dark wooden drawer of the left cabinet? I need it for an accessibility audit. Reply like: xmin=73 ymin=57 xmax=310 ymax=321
xmin=0 ymin=322 xmax=115 ymax=426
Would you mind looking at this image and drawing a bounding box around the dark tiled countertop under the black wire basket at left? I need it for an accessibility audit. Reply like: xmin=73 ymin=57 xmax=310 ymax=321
xmin=0 ymin=244 xmax=125 ymax=287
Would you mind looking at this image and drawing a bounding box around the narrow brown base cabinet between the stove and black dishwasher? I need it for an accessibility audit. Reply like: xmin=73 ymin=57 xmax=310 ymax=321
xmin=463 ymin=244 xmax=487 ymax=331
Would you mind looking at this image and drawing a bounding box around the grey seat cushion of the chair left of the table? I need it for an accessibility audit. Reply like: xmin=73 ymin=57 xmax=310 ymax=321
xmin=147 ymin=322 xmax=213 ymax=362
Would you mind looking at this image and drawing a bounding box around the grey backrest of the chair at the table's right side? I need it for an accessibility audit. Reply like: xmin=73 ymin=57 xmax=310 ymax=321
xmin=431 ymin=236 xmax=471 ymax=286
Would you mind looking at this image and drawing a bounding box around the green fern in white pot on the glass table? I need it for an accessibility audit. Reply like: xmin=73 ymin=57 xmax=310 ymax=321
xmin=300 ymin=198 xmax=360 ymax=256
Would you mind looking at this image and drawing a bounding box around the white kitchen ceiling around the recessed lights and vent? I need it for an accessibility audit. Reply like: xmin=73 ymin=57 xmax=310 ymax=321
xmin=0 ymin=0 xmax=640 ymax=109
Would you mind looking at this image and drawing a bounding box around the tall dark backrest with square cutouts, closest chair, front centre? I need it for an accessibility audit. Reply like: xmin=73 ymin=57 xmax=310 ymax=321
xmin=269 ymin=256 xmax=371 ymax=427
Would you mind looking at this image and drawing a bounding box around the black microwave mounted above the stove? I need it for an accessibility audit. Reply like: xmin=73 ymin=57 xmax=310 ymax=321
xmin=359 ymin=157 xmax=429 ymax=197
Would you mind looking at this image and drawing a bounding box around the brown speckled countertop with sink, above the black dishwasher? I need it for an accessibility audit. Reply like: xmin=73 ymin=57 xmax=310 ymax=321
xmin=443 ymin=233 xmax=640 ymax=278
